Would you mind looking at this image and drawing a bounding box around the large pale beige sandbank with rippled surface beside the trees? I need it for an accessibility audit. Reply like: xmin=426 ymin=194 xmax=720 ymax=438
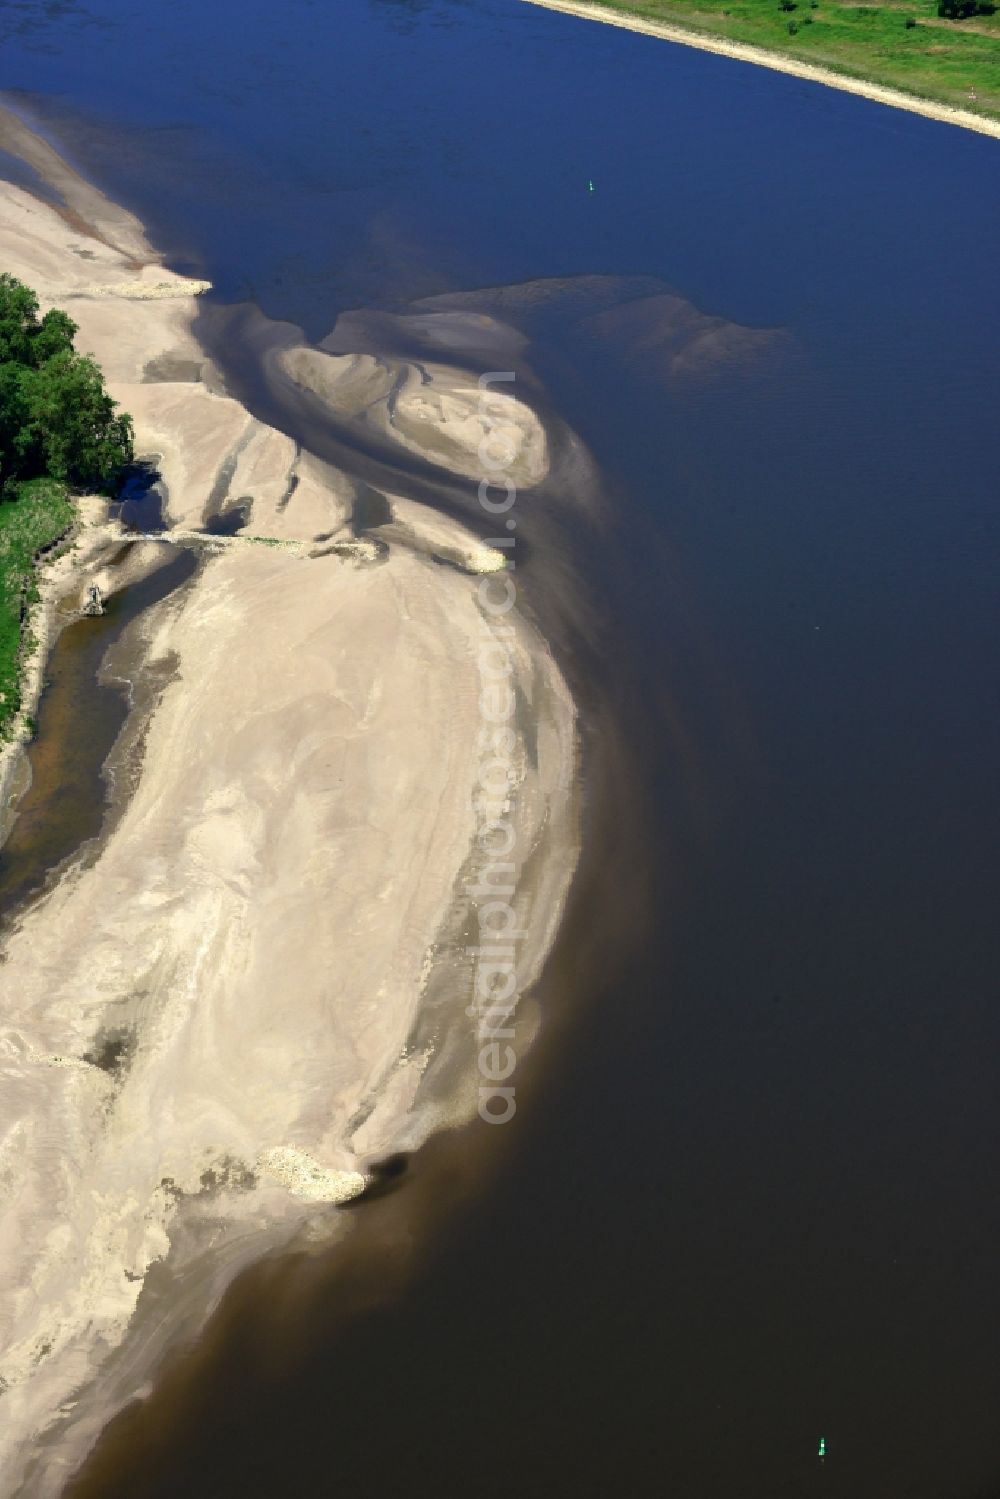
xmin=0 ymin=102 xmax=579 ymax=1499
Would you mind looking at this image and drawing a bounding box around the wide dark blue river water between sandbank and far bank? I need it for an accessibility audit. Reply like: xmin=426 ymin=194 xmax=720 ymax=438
xmin=0 ymin=0 xmax=1000 ymax=1499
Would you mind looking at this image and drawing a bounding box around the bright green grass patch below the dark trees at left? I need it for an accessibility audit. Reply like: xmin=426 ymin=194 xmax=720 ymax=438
xmin=0 ymin=478 xmax=73 ymax=739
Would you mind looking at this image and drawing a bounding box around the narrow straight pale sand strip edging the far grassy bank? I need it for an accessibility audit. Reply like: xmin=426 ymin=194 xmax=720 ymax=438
xmin=526 ymin=0 xmax=1000 ymax=139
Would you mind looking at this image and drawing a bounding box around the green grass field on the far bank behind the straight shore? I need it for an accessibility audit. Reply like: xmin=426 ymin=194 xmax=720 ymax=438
xmin=575 ymin=0 xmax=1000 ymax=118
